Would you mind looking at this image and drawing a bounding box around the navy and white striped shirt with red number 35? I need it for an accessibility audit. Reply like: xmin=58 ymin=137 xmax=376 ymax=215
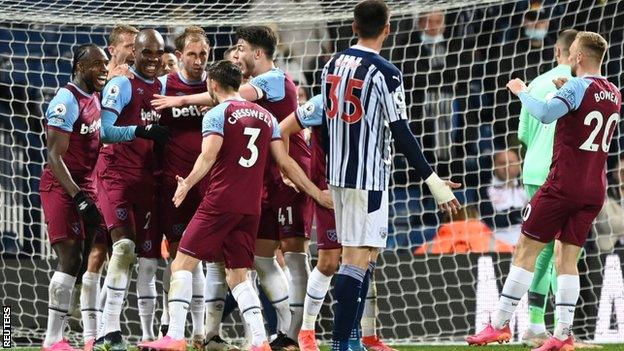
xmin=321 ymin=45 xmax=407 ymax=190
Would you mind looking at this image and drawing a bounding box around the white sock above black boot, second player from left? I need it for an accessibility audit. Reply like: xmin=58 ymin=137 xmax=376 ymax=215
xmin=98 ymin=239 xmax=135 ymax=338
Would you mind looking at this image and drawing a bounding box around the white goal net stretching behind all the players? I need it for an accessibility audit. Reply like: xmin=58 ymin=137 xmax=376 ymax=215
xmin=0 ymin=0 xmax=624 ymax=346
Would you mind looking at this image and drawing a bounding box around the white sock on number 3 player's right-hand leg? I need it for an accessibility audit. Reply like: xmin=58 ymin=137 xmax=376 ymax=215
xmin=232 ymin=280 xmax=267 ymax=346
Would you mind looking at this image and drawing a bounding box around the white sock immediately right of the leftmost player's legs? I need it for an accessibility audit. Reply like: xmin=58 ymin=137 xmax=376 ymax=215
xmin=80 ymin=272 xmax=100 ymax=343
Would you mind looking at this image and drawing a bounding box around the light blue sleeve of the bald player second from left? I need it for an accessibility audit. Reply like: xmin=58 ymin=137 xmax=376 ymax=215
xmin=100 ymin=76 xmax=136 ymax=143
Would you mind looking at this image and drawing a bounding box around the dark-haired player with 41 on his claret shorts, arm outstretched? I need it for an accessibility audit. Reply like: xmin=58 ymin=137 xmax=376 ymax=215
xmin=153 ymin=26 xmax=310 ymax=349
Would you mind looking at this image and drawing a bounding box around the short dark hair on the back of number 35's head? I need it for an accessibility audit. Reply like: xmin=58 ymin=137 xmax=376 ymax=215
xmin=353 ymin=0 xmax=390 ymax=39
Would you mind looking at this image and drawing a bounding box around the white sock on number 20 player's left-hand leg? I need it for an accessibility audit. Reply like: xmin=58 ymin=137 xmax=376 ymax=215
xmin=492 ymin=265 xmax=533 ymax=329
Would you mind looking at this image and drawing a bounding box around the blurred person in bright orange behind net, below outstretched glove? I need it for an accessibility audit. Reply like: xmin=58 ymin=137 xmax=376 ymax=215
xmin=414 ymin=205 xmax=513 ymax=255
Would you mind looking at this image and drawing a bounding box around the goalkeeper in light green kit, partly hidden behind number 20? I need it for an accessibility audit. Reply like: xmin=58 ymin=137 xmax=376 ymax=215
xmin=518 ymin=29 xmax=577 ymax=347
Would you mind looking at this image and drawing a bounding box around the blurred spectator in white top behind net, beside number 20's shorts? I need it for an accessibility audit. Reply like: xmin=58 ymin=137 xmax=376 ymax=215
xmin=480 ymin=150 xmax=528 ymax=245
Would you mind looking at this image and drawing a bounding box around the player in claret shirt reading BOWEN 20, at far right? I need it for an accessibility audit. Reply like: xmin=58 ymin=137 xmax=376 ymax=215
xmin=467 ymin=32 xmax=621 ymax=351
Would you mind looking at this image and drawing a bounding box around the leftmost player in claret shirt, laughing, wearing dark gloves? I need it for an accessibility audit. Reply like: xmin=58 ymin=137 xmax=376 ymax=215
xmin=39 ymin=44 xmax=108 ymax=351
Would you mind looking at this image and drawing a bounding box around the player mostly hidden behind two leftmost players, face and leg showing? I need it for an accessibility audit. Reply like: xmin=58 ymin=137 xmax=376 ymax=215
xmin=80 ymin=25 xmax=139 ymax=348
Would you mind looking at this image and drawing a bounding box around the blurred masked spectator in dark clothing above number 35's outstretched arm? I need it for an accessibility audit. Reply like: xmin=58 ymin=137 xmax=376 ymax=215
xmin=392 ymin=11 xmax=470 ymax=176
